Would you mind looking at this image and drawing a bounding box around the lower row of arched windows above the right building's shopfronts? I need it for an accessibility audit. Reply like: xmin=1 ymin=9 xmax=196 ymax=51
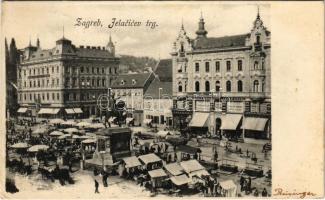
xmin=178 ymin=80 xmax=264 ymax=92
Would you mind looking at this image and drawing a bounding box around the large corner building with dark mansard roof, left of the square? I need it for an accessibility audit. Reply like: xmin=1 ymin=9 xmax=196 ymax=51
xmin=17 ymin=37 xmax=119 ymax=117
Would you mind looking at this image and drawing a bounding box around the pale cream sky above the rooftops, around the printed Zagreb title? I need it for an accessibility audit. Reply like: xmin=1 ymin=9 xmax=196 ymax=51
xmin=2 ymin=2 xmax=271 ymax=59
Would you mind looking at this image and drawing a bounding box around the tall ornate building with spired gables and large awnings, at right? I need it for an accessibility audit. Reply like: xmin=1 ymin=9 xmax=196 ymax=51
xmin=171 ymin=13 xmax=271 ymax=141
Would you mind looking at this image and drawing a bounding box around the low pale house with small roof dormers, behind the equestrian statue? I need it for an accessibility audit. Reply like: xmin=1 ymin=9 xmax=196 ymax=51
xmin=111 ymin=73 xmax=155 ymax=125
